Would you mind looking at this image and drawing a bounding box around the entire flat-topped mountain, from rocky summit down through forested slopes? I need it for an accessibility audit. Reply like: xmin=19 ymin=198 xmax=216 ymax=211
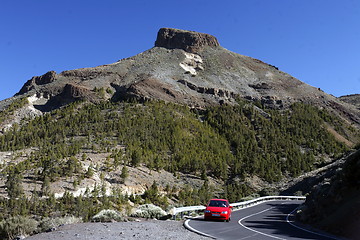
xmin=0 ymin=28 xmax=360 ymax=236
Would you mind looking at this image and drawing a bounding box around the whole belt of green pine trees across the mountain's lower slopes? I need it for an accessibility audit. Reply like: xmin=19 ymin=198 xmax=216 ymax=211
xmin=0 ymin=98 xmax=351 ymax=227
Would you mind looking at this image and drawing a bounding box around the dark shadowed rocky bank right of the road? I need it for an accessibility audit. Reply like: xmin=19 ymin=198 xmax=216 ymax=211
xmin=300 ymin=150 xmax=360 ymax=239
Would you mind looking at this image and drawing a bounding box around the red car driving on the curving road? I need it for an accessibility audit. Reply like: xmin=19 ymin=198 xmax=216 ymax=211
xmin=204 ymin=199 xmax=232 ymax=222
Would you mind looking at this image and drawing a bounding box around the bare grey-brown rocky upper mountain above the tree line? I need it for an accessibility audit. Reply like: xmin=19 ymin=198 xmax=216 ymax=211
xmin=2 ymin=28 xmax=360 ymax=127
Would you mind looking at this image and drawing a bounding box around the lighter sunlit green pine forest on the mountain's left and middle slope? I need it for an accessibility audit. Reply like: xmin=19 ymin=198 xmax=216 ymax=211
xmin=0 ymin=102 xmax=233 ymax=181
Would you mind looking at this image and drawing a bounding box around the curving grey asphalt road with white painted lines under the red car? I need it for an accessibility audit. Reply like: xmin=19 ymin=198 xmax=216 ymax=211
xmin=188 ymin=201 xmax=337 ymax=240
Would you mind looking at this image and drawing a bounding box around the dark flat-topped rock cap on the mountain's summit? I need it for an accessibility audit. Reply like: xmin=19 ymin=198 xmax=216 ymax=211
xmin=155 ymin=28 xmax=220 ymax=53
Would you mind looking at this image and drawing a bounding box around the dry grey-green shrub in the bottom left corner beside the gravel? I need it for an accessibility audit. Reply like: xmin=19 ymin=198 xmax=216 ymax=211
xmin=0 ymin=216 xmax=39 ymax=239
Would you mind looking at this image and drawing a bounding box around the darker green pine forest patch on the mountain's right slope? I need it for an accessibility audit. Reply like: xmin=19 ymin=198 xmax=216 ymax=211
xmin=204 ymin=103 xmax=347 ymax=182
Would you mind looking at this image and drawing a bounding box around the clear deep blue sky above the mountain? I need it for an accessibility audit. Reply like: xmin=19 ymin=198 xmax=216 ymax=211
xmin=0 ymin=0 xmax=360 ymax=100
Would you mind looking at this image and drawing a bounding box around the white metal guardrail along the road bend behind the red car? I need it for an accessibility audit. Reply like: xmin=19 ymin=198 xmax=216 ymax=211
xmin=173 ymin=196 xmax=306 ymax=219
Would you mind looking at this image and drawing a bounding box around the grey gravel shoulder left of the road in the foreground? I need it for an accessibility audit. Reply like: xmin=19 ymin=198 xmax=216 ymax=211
xmin=26 ymin=220 xmax=209 ymax=240
